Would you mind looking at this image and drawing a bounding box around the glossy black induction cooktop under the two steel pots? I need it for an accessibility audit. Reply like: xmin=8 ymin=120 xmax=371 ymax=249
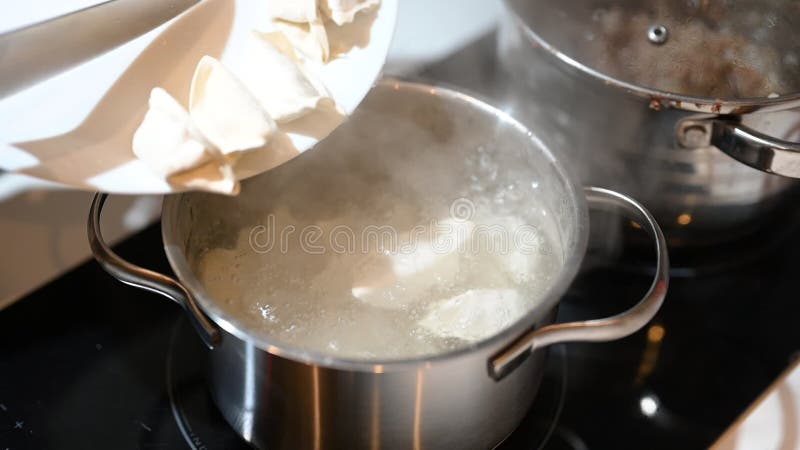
xmin=0 ymin=202 xmax=800 ymax=450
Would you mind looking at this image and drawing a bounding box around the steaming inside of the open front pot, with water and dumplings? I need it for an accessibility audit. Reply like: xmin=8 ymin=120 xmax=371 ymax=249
xmin=163 ymin=80 xmax=586 ymax=362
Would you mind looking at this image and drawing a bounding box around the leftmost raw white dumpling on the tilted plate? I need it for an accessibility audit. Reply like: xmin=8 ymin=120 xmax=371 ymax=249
xmin=133 ymin=88 xmax=212 ymax=178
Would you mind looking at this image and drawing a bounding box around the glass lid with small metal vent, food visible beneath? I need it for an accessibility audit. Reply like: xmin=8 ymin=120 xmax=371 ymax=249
xmin=507 ymin=0 xmax=800 ymax=100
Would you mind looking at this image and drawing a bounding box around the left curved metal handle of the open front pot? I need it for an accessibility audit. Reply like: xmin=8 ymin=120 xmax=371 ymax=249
xmin=87 ymin=193 xmax=221 ymax=348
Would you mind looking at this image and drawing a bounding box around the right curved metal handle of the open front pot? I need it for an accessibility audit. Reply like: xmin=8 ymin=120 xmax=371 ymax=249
xmin=489 ymin=187 xmax=669 ymax=380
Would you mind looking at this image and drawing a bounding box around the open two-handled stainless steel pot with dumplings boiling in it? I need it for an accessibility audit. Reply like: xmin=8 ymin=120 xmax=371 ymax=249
xmin=88 ymin=80 xmax=669 ymax=450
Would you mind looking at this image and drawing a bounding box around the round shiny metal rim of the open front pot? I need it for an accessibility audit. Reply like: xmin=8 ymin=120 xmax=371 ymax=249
xmin=161 ymin=78 xmax=589 ymax=373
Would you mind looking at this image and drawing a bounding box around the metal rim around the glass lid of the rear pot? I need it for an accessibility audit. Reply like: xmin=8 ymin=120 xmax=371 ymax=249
xmin=503 ymin=0 xmax=800 ymax=114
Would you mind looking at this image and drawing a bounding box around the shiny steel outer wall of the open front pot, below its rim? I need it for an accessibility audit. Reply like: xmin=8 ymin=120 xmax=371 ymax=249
xmin=210 ymin=314 xmax=553 ymax=450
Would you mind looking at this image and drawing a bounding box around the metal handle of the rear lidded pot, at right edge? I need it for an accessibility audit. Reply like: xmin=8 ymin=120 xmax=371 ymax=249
xmin=678 ymin=116 xmax=800 ymax=178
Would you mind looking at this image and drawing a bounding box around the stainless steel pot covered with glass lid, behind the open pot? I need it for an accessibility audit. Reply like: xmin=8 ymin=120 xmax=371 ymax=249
xmin=498 ymin=0 xmax=800 ymax=244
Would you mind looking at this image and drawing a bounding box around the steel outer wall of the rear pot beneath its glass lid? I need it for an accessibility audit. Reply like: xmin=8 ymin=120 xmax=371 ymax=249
xmin=498 ymin=2 xmax=800 ymax=244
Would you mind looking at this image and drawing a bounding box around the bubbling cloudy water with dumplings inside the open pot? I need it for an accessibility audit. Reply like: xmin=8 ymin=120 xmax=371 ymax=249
xmin=194 ymin=119 xmax=563 ymax=361
